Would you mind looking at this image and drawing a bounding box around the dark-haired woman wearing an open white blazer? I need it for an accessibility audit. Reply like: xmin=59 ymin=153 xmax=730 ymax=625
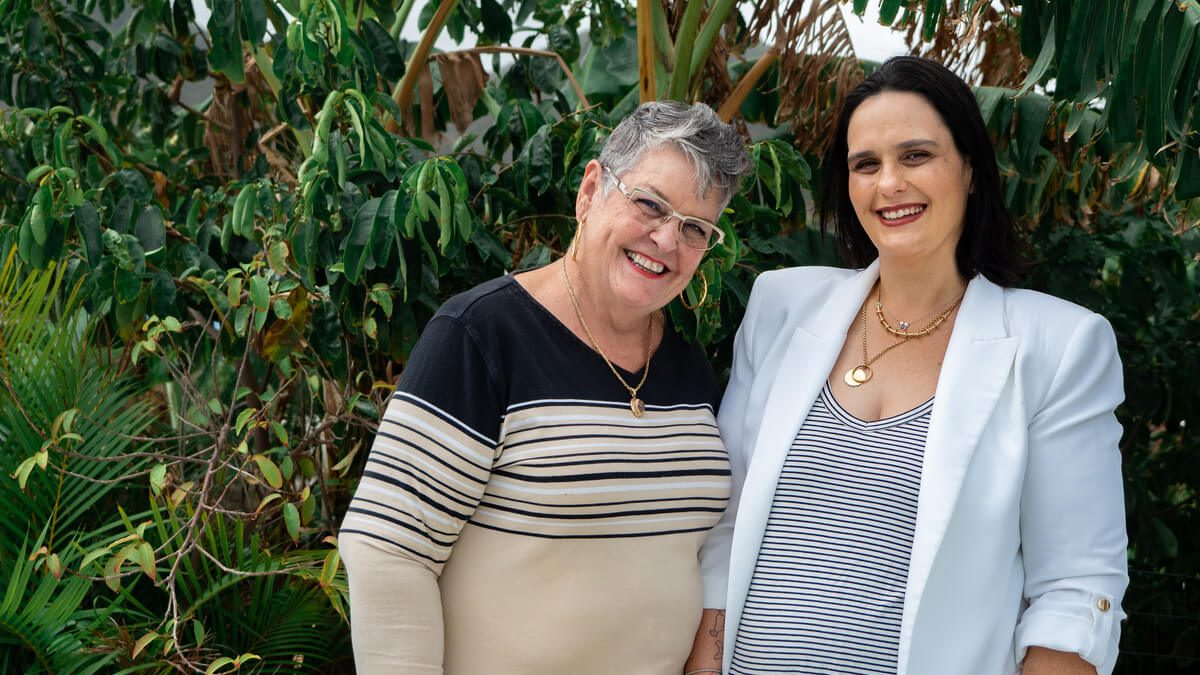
xmin=691 ymin=58 xmax=1127 ymax=675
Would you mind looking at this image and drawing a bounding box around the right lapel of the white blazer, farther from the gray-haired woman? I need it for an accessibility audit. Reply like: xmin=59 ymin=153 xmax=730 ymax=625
xmin=899 ymin=276 xmax=1016 ymax=675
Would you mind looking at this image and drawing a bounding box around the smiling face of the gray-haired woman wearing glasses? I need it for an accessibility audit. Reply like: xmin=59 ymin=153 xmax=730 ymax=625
xmin=576 ymin=147 xmax=721 ymax=315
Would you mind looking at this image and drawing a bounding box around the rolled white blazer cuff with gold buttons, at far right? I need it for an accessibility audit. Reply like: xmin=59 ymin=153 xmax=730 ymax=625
xmin=1014 ymin=591 xmax=1124 ymax=675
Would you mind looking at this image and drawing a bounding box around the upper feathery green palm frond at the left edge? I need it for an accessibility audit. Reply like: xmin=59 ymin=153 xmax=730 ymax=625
xmin=0 ymin=243 xmax=155 ymax=554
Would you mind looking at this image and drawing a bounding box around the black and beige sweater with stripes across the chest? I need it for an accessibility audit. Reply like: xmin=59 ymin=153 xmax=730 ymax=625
xmin=340 ymin=277 xmax=730 ymax=675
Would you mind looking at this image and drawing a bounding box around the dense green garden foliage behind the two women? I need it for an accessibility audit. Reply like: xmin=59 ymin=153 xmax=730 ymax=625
xmin=0 ymin=0 xmax=1200 ymax=673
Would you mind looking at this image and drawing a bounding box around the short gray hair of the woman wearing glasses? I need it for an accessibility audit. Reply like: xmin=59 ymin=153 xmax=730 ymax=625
xmin=600 ymin=101 xmax=750 ymax=208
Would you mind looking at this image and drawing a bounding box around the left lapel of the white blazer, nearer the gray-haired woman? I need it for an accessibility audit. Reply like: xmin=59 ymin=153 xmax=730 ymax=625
xmin=727 ymin=262 xmax=878 ymax=634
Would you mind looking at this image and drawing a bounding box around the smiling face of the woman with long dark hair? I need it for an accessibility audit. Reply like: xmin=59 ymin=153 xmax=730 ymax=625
xmin=846 ymin=91 xmax=971 ymax=265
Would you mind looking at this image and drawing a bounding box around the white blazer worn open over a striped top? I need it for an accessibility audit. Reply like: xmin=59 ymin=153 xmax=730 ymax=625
xmin=701 ymin=262 xmax=1128 ymax=675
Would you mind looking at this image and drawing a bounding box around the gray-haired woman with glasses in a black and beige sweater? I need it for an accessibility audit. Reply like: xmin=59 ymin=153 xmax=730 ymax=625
xmin=338 ymin=103 xmax=749 ymax=675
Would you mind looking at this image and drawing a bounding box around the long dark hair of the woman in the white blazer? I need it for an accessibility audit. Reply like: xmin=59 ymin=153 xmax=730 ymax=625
xmin=821 ymin=56 xmax=1030 ymax=286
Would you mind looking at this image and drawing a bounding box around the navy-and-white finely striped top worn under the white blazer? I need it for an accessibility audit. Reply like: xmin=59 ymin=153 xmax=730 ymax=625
xmin=731 ymin=384 xmax=934 ymax=675
